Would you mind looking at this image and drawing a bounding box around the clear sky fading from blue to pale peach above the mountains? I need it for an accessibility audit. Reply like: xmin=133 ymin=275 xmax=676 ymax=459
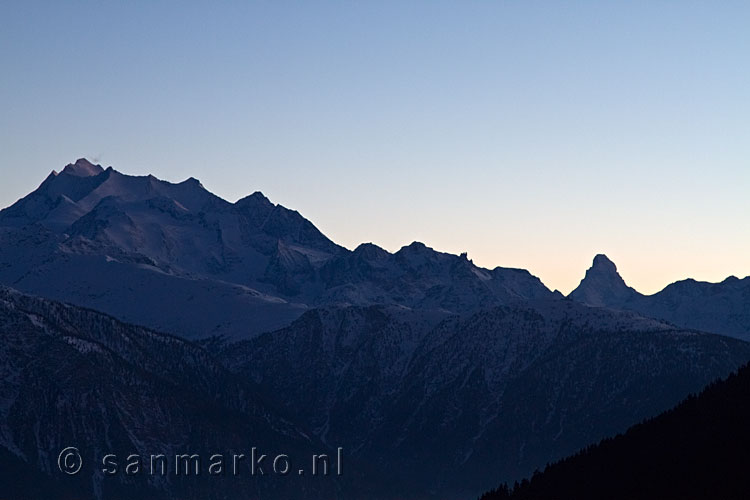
xmin=0 ymin=0 xmax=750 ymax=293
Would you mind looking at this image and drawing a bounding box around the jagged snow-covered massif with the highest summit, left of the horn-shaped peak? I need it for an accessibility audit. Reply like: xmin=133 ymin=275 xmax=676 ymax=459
xmin=0 ymin=159 xmax=560 ymax=339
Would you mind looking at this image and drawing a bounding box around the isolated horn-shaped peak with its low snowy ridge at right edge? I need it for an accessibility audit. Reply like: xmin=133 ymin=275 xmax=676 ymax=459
xmin=568 ymin=255 xmax=750 ymax=340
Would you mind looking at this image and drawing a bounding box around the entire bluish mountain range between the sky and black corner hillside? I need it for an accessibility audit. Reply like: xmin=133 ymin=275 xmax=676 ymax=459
xmin=0 ymin=159 xmax=750 ymax=500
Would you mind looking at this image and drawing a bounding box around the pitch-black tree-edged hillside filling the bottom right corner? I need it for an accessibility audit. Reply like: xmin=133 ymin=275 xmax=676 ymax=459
xmin=482 ymin=365 xmax=750 ymax=500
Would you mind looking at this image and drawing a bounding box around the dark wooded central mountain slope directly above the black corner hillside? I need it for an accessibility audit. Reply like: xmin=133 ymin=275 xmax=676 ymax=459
xmin=224 ymin=300 xmax=750 ymax=499
